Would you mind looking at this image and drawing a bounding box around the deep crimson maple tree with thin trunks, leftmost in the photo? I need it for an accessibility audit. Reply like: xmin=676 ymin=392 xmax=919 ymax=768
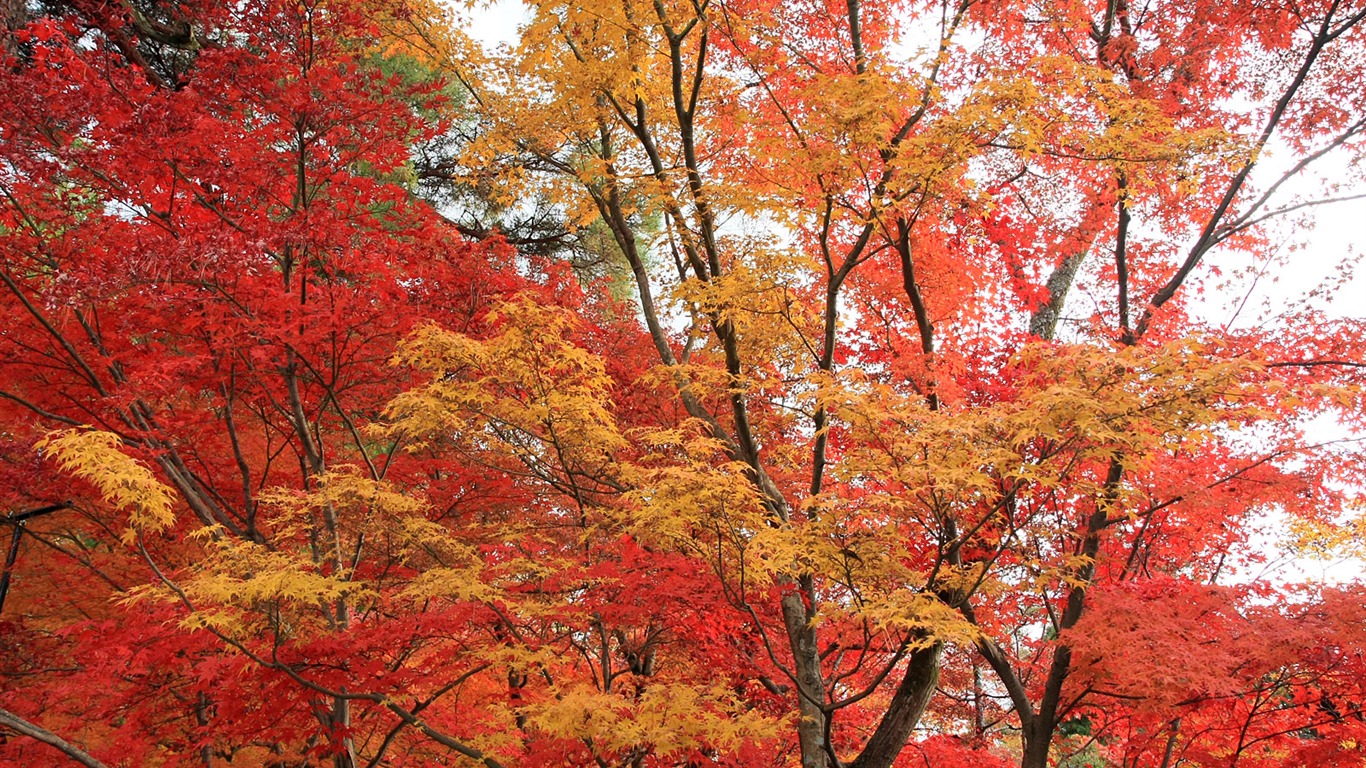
xmin=0 ymin=3 xmax=556 ymax=765
